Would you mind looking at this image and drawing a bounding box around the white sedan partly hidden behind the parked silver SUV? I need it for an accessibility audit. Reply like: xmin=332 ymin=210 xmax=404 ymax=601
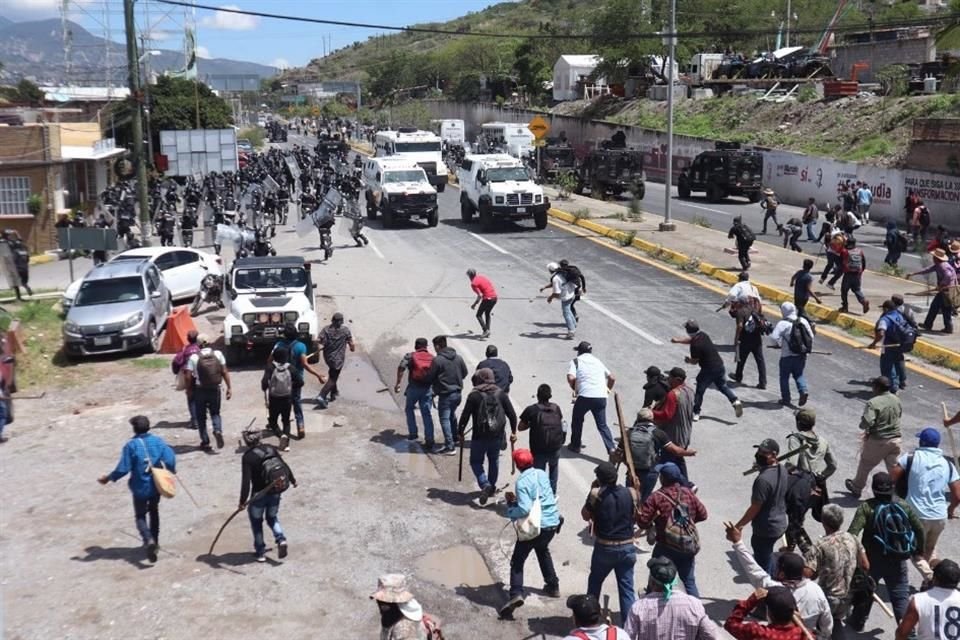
xmin=62 ymin=247 xmax=223 ymax=313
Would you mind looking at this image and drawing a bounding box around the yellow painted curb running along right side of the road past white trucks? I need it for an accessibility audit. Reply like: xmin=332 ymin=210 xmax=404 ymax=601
xmin=548 ymin=207 xmax=960 ymax=368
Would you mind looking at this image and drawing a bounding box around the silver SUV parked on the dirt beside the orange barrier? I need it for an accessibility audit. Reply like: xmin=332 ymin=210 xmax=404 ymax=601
xmin=63 ymin=260 xmax=173 ymax=356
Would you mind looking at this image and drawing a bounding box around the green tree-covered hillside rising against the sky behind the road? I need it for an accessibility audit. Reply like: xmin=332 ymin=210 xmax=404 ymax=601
xmin=285 ymin=0 xmax=944 ymax=104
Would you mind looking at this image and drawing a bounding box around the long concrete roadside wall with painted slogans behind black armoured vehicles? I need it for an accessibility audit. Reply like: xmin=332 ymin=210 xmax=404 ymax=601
xmin=425 ymin=102 xmax=960 ymax=229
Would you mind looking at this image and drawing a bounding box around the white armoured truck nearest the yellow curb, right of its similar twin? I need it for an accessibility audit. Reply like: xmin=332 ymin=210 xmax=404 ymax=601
xmin=457 ymin=154 xmax=550 ymax=231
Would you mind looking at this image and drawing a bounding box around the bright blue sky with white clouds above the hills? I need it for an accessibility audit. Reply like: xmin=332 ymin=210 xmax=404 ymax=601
xmin=0 ymin=0 xmax=506 ymax=68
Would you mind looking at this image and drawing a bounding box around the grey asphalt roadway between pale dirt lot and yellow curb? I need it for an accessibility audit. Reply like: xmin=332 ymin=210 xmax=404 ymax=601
xmin=258 ymin=135 xmax=960 ymax=635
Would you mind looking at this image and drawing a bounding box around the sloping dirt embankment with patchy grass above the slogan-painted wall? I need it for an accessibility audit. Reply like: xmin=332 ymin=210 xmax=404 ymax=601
xmin=552 ymin=89 xmax=960 ymax=166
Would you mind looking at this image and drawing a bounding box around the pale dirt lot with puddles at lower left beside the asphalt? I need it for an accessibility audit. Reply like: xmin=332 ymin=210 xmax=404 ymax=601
xmin=0 ymin=311 xmax=536 ymax=640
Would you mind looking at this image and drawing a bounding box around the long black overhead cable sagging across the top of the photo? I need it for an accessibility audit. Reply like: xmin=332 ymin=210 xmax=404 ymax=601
xmin=155 ymin=0 xmax=960 ymax=41
